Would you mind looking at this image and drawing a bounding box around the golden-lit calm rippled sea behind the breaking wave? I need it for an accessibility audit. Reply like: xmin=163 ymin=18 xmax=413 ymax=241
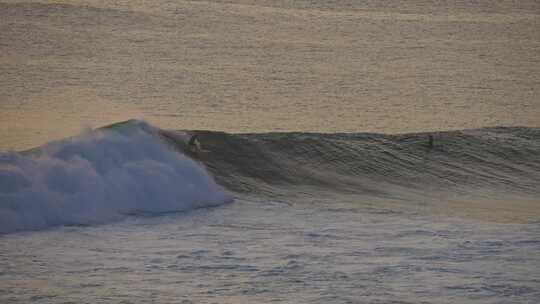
xmin=0 ymin=0 xmax=540 ymax=149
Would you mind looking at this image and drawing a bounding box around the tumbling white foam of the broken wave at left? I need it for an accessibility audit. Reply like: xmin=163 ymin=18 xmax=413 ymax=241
xmin=0 ymin=121 xmax=232 ymax=233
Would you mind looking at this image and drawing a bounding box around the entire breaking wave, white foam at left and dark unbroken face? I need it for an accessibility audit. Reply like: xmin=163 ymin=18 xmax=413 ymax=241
xmin=0 ymin=120 xmax=540 ymax=233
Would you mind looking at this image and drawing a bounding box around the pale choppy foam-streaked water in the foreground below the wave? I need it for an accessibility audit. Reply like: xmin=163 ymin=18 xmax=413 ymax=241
xmin=0 ymin=200 xmax=540 ymax=303
